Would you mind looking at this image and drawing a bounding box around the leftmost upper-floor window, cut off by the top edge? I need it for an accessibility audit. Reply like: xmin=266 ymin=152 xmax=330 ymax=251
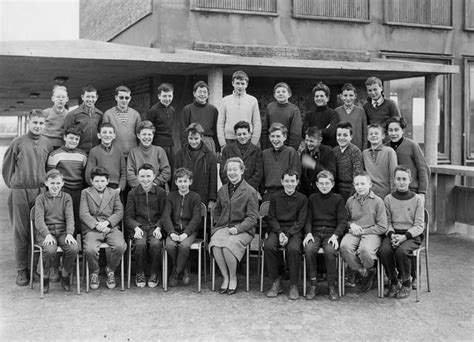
xmin=190 ymin=0 xmax=277 ymax=15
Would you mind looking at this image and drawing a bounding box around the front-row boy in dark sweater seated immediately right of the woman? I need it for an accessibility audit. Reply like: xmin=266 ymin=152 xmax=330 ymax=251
xmin=264 ymin=170 xmax=308 ymax=300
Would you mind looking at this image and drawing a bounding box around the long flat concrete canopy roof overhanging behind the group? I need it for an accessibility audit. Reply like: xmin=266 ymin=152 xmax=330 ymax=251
xmin=0 ymin=40 xmax=459 ymax=115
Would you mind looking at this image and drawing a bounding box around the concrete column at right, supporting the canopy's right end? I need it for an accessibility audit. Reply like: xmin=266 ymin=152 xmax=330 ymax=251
xmin=425 ymin=75 xmax=438 ymax=165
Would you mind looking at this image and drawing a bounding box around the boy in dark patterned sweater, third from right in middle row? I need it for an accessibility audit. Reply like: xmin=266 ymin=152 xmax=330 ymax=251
xmin=333 ymin=121 xmax=364 ymax=203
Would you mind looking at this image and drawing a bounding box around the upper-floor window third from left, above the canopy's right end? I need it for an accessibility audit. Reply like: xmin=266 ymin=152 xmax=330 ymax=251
xmin=384 ymin=0 xmax=453 ymax=29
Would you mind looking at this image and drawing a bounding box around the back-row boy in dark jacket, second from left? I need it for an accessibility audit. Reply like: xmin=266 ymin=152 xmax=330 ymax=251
xmin=64 ymin=85 xmax=103 ymax=153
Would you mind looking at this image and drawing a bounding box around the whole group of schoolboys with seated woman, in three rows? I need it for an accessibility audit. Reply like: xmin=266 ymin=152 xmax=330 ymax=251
xmin=2 ymin=71 xmax=429 ymax=299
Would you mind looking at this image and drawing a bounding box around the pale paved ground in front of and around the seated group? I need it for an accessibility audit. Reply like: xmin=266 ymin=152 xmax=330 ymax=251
xmin=0 ymin=140 xmax=474 ymax=341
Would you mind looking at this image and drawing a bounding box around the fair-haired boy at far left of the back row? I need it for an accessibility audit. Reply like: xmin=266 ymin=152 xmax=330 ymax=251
xmin=43 ymin=85 xmax=69 ymax=149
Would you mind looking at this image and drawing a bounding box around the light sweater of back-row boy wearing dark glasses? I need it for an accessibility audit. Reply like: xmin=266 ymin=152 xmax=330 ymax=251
xmin=103 ymin=106 xmax=142 ymax=157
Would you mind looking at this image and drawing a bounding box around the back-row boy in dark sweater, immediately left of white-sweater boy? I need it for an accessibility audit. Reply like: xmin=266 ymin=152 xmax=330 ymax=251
xmin=181 ymin=81 xmax=218 ymax=155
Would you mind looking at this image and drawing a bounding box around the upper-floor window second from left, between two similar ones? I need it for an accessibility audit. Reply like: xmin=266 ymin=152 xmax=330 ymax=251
xmin=293 ymin=0 xmax=370 ymax=22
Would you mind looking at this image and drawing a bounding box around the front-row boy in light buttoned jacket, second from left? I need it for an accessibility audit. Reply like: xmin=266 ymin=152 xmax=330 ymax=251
xmin=80 ymin=167 xmax=127 ymax=290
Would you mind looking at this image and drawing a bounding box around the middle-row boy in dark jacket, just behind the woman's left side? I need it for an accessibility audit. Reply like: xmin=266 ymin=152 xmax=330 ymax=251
xmin=175 ymin=123 xmax=217 ymax=210
